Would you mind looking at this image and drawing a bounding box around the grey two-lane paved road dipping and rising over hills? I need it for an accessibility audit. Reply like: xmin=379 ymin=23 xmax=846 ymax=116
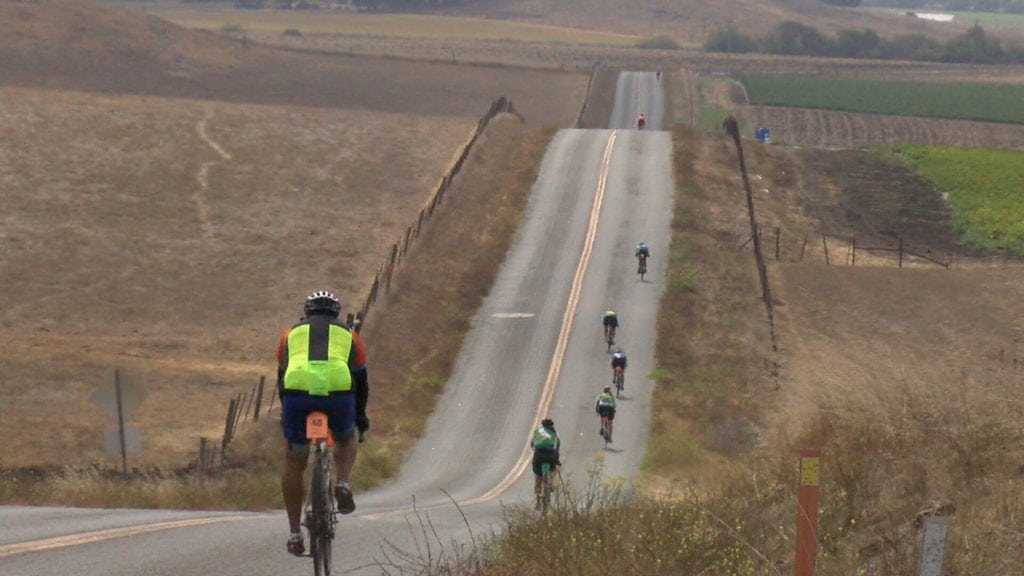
xmin=0 ymin=72 xmax=673 ymax=576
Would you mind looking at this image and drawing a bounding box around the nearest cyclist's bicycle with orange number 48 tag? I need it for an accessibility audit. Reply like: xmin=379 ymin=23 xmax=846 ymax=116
xmin=302 ymin=412 xmax=338 ymax=576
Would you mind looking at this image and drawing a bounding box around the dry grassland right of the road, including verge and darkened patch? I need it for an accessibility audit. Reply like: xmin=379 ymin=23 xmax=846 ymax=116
xmin=645 ymin=119 xmax=1024 ymax=574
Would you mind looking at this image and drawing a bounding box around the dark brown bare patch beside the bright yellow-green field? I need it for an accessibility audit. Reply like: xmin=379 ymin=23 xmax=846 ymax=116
xmin=745 ymin=142 xmax=971 ymax=261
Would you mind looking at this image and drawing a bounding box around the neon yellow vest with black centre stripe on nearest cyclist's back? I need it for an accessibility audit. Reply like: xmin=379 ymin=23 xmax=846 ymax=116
xmin=285 ymin=317 xmax=352 ymax=396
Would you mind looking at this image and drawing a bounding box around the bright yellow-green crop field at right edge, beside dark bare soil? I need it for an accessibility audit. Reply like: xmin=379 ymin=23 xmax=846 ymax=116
xmin=893 ymin=146 xmax=1024 ymax=254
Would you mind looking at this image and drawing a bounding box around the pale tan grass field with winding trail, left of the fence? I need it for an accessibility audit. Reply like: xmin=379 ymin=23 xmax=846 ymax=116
xmin=0 ymin=88 xmax=474 ymax=463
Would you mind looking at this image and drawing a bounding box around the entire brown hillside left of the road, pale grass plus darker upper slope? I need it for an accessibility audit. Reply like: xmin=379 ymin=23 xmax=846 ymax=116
xmin=0 ymin=0 xmax=587 ymax=467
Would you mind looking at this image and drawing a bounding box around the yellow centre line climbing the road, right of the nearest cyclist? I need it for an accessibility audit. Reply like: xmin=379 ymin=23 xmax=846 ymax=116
xmin=360 ymin=131 xmax=618 ymax=520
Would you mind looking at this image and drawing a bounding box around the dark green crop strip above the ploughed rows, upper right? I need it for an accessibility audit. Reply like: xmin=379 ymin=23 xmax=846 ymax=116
xmin=740 ymin=75 xmax=1024 ymax=124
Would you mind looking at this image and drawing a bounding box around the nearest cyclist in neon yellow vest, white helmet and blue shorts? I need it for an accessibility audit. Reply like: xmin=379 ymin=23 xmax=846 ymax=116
xmin=278 ymin=290 xmax=370 ymax=556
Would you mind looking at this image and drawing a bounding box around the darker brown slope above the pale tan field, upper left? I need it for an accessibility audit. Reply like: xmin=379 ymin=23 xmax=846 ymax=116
xmin=0 ymin=0 xmax=589 ymax=126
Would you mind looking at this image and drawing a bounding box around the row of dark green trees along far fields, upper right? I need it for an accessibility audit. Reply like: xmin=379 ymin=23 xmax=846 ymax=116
xmin=705 ymin=22 xmax=1024 ymax=64
